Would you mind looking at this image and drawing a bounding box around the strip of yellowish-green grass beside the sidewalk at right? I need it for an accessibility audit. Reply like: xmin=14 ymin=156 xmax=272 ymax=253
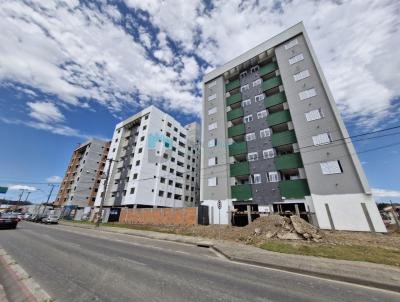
xmin=260 ymin=241 xmax=400 ymax=266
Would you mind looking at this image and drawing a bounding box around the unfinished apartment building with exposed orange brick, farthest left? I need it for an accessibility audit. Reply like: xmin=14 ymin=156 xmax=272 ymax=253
xmin=56 ymin=139 xmax=110 ymax=207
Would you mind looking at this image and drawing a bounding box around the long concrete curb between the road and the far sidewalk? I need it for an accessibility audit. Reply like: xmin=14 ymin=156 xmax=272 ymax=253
xmin=61 ymin=224 xmax=400 ymax=293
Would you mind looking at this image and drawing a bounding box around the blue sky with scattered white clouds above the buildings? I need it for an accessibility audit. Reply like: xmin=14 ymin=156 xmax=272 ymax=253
xmin=0 ymin=0 xmax=400 ymax=203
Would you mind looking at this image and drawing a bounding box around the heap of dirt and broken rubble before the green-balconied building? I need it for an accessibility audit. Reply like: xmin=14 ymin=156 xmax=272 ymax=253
xmin=245 ymin=215 xmax=322 ymax=242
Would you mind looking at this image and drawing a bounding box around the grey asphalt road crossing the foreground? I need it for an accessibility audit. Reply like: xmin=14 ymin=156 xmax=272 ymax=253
xmin=0 ymin=222 xmax=400 ymax=302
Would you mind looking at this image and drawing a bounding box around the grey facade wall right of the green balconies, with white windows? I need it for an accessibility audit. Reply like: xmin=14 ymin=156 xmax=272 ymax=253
xmin=275 ymin=35 xmax=364 ymax=195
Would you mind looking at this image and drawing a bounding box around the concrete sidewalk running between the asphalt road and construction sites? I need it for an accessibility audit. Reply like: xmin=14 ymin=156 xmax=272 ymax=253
xmin=60 ymin=222 xmax=400 ymax=292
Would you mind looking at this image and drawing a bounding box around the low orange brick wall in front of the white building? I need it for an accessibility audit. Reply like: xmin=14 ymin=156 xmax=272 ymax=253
xmin=119 ymin=208 xmax=197 ymax=225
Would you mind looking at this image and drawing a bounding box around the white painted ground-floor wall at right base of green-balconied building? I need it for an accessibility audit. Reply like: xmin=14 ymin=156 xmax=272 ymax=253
xmin=311 ymin=194 xmax=387 ymax=233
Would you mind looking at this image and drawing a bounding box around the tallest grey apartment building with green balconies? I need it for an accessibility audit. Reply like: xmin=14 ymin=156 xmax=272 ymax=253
xmin=200 ymin=23 xmax=386 ymax=232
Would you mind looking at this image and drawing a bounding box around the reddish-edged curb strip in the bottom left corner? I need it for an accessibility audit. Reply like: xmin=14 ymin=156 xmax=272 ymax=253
xmin=0 ymin=248 xmax=54 ymax=302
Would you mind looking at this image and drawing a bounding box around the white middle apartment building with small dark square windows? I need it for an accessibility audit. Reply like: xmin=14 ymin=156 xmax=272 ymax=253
xmin=95 ymin=106 xmax=201 ymax=207
